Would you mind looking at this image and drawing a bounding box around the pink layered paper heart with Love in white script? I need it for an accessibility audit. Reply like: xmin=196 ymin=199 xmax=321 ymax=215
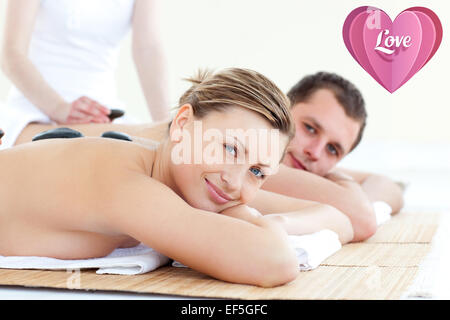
xmin=342 ymin=6 xmax=442 ymax=93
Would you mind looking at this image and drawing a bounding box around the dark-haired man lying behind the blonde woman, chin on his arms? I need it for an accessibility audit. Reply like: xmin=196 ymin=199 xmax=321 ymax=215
xmin=9 ymin=72 xmax=403 ymax=241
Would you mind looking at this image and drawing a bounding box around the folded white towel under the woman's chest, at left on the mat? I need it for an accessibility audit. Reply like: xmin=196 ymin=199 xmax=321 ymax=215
xmin=0 ymin=244 xmax=169 ymax=275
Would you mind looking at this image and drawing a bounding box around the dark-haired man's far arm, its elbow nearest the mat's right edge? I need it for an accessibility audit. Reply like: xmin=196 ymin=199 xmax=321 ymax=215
xmin=335 ymin=168 xmax=404 ymax=214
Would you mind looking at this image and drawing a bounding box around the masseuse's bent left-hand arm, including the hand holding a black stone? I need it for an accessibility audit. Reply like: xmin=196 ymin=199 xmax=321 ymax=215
xmin=1 ymin=0 xmax=109 ymax=123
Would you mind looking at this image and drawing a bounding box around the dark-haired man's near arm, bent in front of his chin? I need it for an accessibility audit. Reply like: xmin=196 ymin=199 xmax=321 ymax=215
xmin=262 ymin=165 xmax=377 ymax=241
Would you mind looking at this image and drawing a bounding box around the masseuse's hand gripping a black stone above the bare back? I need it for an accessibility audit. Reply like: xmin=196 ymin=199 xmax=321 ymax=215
xmin=52 ymin=96 xmax=111 ymax=124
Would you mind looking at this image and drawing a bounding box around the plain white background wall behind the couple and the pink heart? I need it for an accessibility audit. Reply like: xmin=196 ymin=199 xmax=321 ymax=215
xmin=0 ymin=0 xmax=450 ymax=143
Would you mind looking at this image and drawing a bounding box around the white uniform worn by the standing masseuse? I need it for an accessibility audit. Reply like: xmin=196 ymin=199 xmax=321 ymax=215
xmin=0 ymin=0 xmax=136 ymax=148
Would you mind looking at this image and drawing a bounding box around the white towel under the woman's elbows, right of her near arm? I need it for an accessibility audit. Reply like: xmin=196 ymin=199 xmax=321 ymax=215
xmin=172 ymin=229 xmax=342 ymax=271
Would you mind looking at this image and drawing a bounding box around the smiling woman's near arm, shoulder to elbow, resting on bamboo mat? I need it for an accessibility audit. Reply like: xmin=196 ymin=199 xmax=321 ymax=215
xmin=102 ymin=172 xmax=298 ymax=287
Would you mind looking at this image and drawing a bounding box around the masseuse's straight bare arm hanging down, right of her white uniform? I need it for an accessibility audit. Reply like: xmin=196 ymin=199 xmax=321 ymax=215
xmin=132 ymin=0 xmax=170 ymax=121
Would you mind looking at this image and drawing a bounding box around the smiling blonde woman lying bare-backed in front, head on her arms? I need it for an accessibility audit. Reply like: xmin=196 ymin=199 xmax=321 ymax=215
xmin=0 ymin=69 xmax=353 ymax=286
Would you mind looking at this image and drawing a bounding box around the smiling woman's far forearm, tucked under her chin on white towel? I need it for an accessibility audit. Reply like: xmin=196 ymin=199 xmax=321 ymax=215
xmin=249 ymin=190 xmax=353 ymax=244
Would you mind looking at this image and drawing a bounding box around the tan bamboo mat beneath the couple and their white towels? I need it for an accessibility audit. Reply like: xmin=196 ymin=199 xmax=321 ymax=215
xmin=0 ymin=213 xmax=439 ymax=299
